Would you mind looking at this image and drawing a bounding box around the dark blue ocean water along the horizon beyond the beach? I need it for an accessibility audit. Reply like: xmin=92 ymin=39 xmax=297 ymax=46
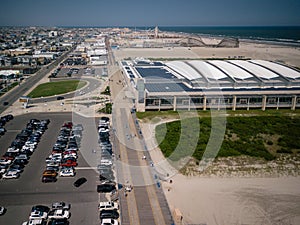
xmin=159 ymin=26 xmax=300 ymax=46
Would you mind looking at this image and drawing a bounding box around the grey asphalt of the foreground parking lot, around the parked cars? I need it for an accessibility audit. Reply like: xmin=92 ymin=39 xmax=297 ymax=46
xmin=0 ymin=113 xmax=100 ymax=225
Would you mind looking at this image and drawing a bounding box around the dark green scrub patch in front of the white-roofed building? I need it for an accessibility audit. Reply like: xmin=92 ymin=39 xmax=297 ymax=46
xmin=156 ymin=114 xmax=300 ymax=161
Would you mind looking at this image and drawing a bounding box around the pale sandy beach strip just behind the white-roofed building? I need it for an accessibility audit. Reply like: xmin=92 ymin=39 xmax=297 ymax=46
xmin=114 ymin=42 xmax=300 ymax=67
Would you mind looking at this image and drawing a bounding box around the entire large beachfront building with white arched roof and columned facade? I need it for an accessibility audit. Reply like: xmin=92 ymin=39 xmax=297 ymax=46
xmin=121 ymin=59 xmax=300 ymax=111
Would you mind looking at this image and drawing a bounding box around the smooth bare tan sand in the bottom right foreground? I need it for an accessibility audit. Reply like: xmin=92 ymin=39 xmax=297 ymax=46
xmin=163 ymin=174 xmax=300 ymax=225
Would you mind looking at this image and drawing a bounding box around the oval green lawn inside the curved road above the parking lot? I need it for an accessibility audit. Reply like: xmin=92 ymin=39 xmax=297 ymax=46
xmin=28 ymin=80 xmax=87 ymax=98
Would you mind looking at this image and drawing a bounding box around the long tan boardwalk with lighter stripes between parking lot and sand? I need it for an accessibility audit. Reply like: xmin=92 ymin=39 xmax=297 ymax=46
xmin=110 ymin=68 xmax=173 ymax=225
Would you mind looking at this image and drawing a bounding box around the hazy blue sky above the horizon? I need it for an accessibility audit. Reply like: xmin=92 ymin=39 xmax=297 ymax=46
xmin=0 ymin=0 xmax=300 ymax=27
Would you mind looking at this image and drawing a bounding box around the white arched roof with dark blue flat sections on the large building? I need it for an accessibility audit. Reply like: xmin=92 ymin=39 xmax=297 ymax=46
xmin=121 ymin=60 xmax=300 ymax=92
